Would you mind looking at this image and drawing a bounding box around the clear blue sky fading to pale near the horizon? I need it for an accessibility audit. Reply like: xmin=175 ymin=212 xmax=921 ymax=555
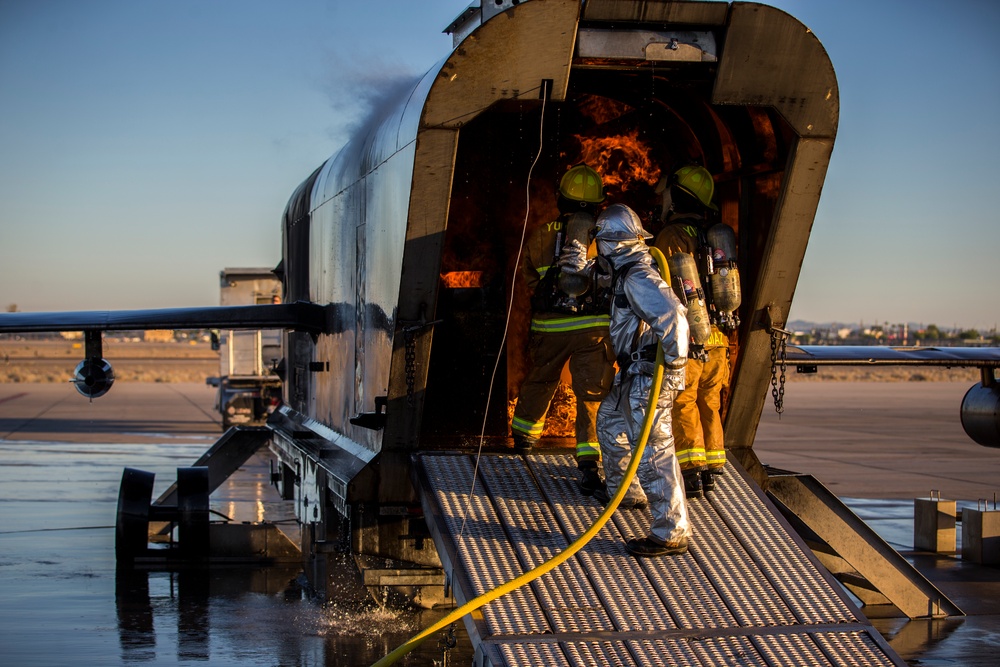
xmin=0 ymin=0 xmax=1000 ymax=329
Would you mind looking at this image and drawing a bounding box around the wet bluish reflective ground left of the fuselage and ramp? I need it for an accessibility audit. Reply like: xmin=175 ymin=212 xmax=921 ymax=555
xmin=0 ymin=440 xmax=472 ymax=667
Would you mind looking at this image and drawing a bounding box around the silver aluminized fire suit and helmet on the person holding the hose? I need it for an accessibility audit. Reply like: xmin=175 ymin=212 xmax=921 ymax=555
xmin=597 ymin=204 xmax=691 ymax=543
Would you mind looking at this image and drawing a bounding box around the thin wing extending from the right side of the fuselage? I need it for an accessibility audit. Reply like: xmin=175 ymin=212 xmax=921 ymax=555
xmin=785 ymin=345 xmax=1000 ymax=368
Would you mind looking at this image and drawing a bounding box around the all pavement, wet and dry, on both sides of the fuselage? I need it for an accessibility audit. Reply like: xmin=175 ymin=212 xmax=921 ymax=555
xmin=0 ymin=383 xmax=1000 ymax=667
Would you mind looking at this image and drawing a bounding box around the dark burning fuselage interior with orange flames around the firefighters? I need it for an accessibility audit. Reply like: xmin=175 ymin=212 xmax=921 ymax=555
xmin=421 ymin=65 xmax=795 ymax=448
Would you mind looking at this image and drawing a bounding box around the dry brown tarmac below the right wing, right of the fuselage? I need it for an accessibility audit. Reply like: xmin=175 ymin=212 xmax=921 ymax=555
xmin=754 ymin=382 xmax=1000 ymax=507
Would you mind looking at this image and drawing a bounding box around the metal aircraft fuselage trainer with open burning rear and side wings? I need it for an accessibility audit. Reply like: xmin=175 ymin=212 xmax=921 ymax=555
xmin=0 ymin=0 xmax=1000 ymax=603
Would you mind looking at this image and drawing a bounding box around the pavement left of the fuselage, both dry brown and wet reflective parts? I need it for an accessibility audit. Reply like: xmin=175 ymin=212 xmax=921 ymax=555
xmin=0 ymin=383 xmax=471 ymax=667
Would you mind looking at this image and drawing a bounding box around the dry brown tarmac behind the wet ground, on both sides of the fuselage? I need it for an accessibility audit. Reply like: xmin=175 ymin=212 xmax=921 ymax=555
xmin=0 ymin=382 xmax=1000 ymax=500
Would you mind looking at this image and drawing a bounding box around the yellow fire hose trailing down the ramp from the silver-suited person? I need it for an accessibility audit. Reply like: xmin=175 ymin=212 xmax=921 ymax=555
xmin=372 ymin=247 xmax=670 ymax=667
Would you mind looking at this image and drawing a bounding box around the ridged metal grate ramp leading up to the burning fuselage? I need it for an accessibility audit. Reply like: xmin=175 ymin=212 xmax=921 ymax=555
xmin=416 ymin=453 xmax=905 ymax=667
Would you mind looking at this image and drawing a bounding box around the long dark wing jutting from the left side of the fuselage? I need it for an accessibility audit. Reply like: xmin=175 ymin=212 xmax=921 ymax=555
xmin=0 ymin=302 xmax=327 ymax=333
